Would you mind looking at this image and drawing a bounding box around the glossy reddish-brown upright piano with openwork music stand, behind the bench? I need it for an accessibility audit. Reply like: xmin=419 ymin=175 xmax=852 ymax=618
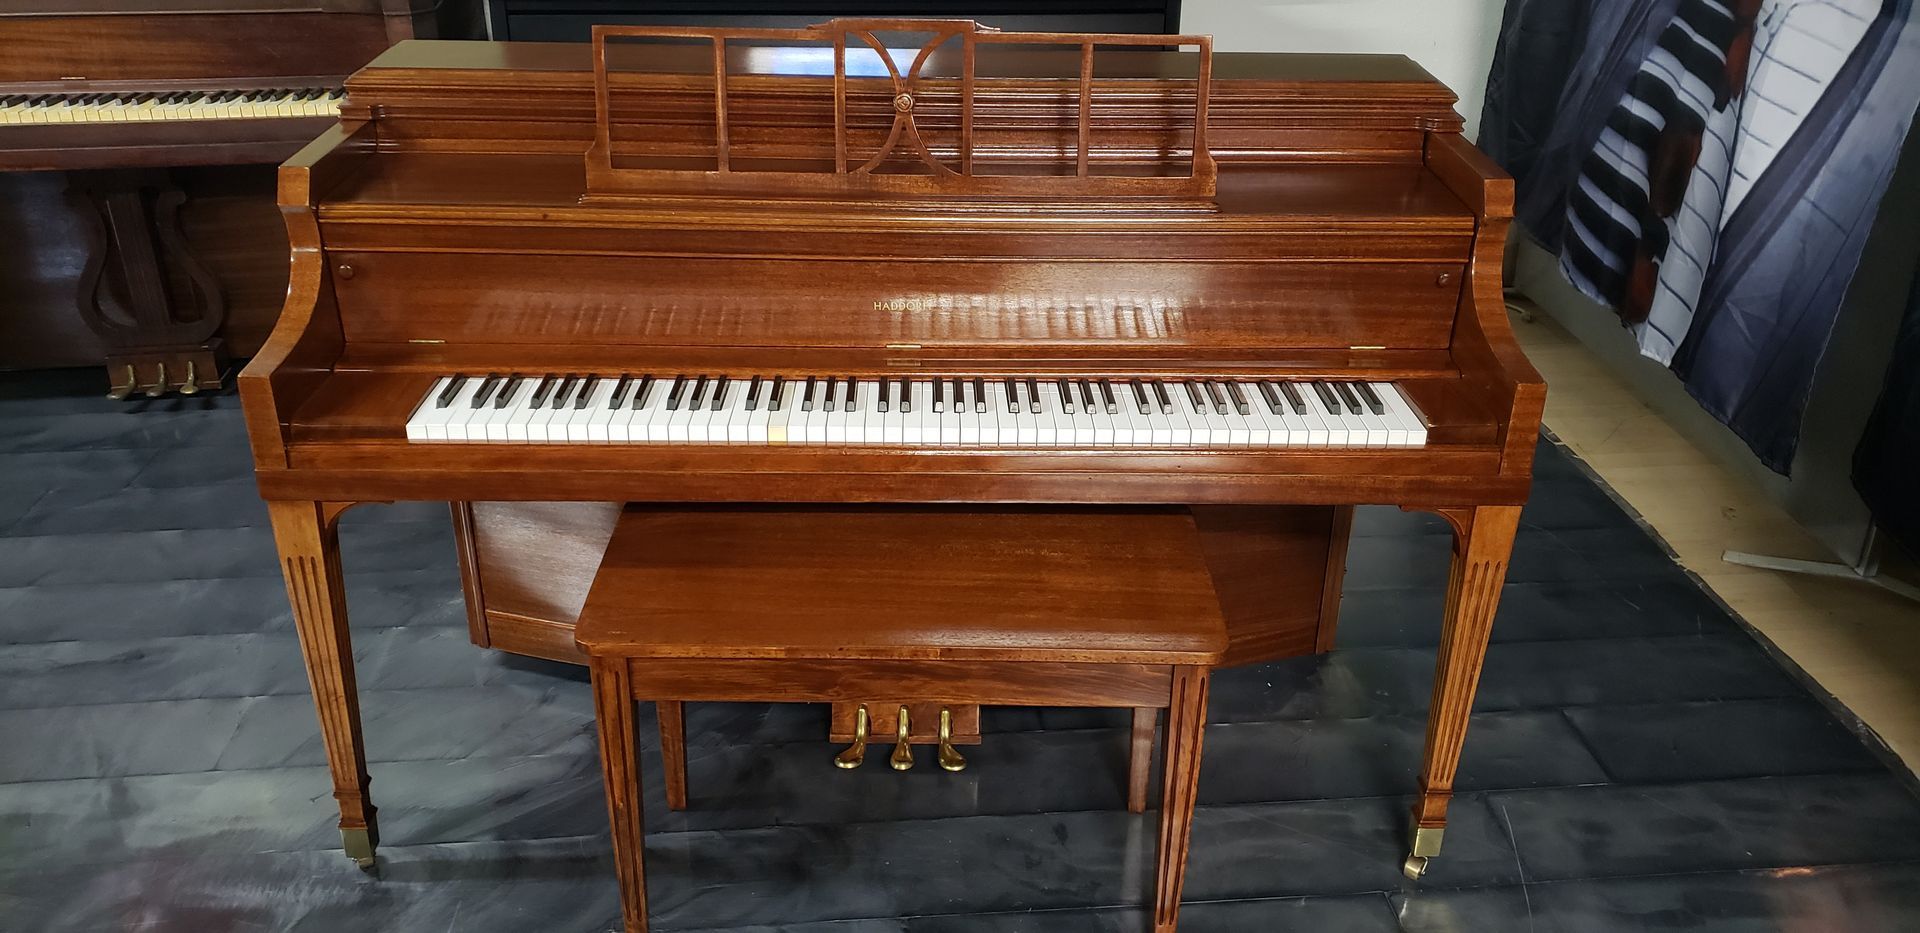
xmin=240 ymin=19 xmax=1546 ymax=873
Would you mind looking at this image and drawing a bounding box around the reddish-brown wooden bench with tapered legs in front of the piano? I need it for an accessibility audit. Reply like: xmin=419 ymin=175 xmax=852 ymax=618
xmin=574 ymin=505 xmax=1227 ymax=933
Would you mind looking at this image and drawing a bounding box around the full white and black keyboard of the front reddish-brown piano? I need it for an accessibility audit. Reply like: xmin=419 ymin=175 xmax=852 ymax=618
xmin=407 ymin=372 xmax=1427 ymax=447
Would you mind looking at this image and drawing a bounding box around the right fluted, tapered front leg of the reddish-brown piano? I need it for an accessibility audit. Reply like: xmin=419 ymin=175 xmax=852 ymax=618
xmin=1404 ymin=505 xmax=1521 ymax=879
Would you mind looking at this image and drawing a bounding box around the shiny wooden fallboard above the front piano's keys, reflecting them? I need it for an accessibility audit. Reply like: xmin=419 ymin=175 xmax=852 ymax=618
xmin=330 ymin=246 xmax=1463 ymax=349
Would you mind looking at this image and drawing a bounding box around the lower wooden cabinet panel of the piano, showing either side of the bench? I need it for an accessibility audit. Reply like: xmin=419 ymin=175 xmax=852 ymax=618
xmin=453 ymin=503 xmax=1352 ymax=666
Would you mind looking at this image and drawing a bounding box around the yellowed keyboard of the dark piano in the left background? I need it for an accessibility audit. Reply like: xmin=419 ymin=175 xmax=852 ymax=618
xmin=0 ymin=88 xmax=346 ymax=127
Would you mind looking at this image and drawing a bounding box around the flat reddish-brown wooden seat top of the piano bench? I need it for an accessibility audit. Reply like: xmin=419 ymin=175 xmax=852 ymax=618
xmin=574 ymin=505 xmax=1227 ymax=664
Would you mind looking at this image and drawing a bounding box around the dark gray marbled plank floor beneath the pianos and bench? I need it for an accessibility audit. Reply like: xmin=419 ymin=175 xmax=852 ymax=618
xmin=0 ymin=372 xmax=1920 ymax=933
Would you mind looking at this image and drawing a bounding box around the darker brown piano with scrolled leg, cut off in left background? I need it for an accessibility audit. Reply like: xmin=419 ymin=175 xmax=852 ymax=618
xmin=0 ymin=0 xmax=428 ymax=397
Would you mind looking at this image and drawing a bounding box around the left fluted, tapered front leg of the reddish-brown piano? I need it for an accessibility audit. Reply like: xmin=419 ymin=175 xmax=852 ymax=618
xmin=267 ymin=501 xmax=380 ymax=868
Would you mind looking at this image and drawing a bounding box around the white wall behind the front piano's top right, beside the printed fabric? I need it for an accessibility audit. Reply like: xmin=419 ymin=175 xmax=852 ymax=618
xmin=1181 ymin=0 xmax=1507 ymax=140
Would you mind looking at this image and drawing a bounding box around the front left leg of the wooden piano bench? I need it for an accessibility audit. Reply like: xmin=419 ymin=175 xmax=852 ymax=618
xmin=589 ymin=658 xmax=647 ymax=933
